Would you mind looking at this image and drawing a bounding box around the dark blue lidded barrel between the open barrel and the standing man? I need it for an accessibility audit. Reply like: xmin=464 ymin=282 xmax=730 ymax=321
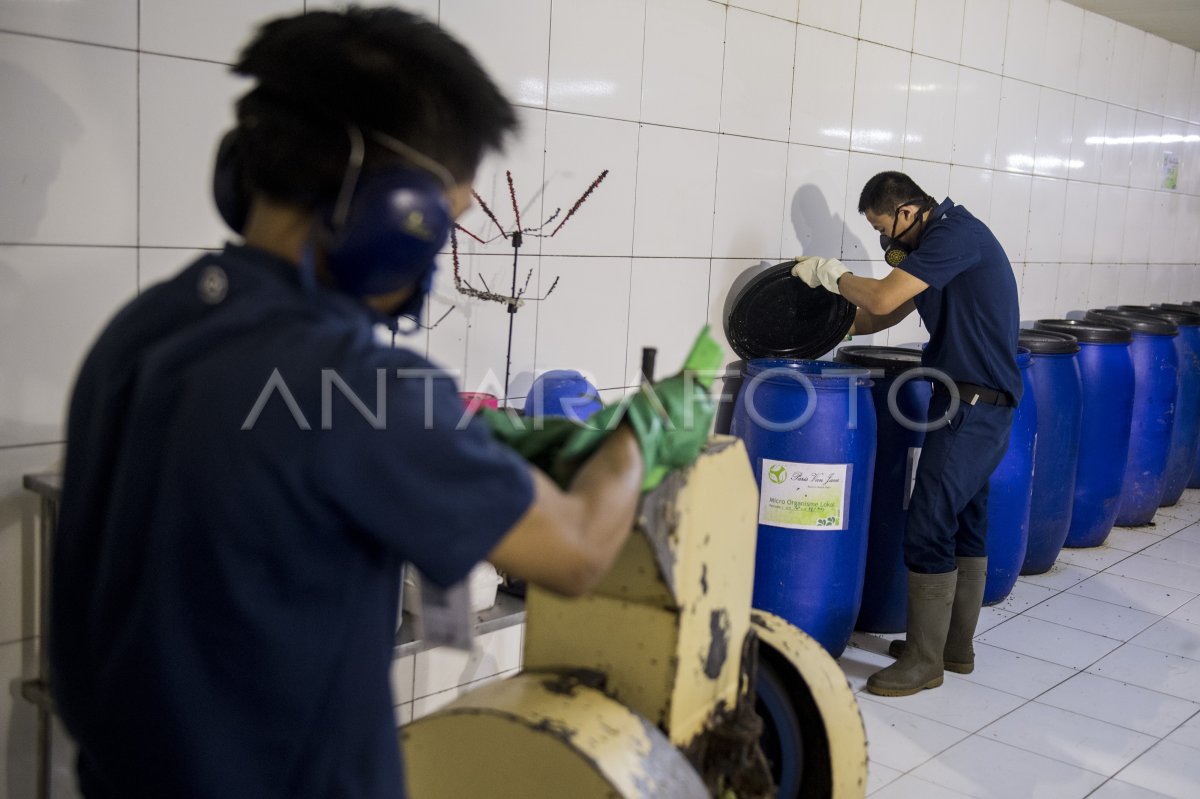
xmin=835 ymin=346 xmax=930 ymax=632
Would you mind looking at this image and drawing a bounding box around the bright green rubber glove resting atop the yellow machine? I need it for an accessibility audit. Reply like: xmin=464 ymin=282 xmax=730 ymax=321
xmin=556 ymin=328 xmax=722 ymax=491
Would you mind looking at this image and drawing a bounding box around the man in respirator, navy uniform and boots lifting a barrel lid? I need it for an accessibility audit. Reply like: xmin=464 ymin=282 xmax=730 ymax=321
xmin=792 ymin=172 xmax=1022 ymax=696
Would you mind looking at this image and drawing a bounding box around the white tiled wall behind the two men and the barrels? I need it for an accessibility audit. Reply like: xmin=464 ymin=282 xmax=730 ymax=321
xmin=0 ymin=0 xmax=1200 ymax=797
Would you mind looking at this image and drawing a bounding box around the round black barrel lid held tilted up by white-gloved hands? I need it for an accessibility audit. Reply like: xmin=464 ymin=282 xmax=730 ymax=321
xmin=725 ymin=260 xmax=856 ymax=360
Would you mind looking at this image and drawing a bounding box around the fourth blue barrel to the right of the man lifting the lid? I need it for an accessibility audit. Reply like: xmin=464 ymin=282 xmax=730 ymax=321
xmin=1086 ymin=308 xmax=1178 ymax=527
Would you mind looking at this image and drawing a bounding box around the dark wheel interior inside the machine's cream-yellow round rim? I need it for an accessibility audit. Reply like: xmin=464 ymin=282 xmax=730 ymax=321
xmin=755 ymin=645 xmax=832 ymax=799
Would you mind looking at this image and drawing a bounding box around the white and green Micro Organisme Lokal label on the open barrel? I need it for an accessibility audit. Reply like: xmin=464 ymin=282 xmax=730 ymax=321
xmin=758 ymin=458 xmax=853 ymax=530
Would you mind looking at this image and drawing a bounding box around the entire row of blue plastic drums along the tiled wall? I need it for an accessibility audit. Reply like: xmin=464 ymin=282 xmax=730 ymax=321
xmin=731 ymin=298 xmax=1200 ymax=656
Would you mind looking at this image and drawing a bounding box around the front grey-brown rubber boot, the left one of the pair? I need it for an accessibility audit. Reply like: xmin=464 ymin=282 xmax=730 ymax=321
xmin=866 ymin=569 xmax=959 ymax=696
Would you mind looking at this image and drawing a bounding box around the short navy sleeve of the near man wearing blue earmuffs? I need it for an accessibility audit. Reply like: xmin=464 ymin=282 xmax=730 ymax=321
xmin=319 ymin=361 xmax=534 ymax=585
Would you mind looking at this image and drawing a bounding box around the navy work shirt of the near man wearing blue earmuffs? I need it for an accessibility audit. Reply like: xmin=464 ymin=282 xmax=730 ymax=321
xmin=49 ymin=246 xmax=533 ymax=799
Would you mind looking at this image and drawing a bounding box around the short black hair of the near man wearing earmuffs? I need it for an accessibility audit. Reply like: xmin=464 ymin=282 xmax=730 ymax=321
xmin=233 ymin=7 xmax=517 ymax=206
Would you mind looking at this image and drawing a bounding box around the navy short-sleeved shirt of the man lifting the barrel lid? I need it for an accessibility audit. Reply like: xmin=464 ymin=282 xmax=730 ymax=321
xmin=898 ymin=198 xmax=1022 ymax=403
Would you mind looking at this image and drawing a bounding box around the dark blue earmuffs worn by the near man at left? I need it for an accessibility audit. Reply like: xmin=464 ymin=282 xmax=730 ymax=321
xmin=212 ymin=119 xmax=454 ymax=299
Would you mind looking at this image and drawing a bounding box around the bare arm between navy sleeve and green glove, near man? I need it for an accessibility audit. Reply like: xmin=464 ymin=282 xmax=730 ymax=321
xmin=487 ymin=425 xmax=643 ymax=596
